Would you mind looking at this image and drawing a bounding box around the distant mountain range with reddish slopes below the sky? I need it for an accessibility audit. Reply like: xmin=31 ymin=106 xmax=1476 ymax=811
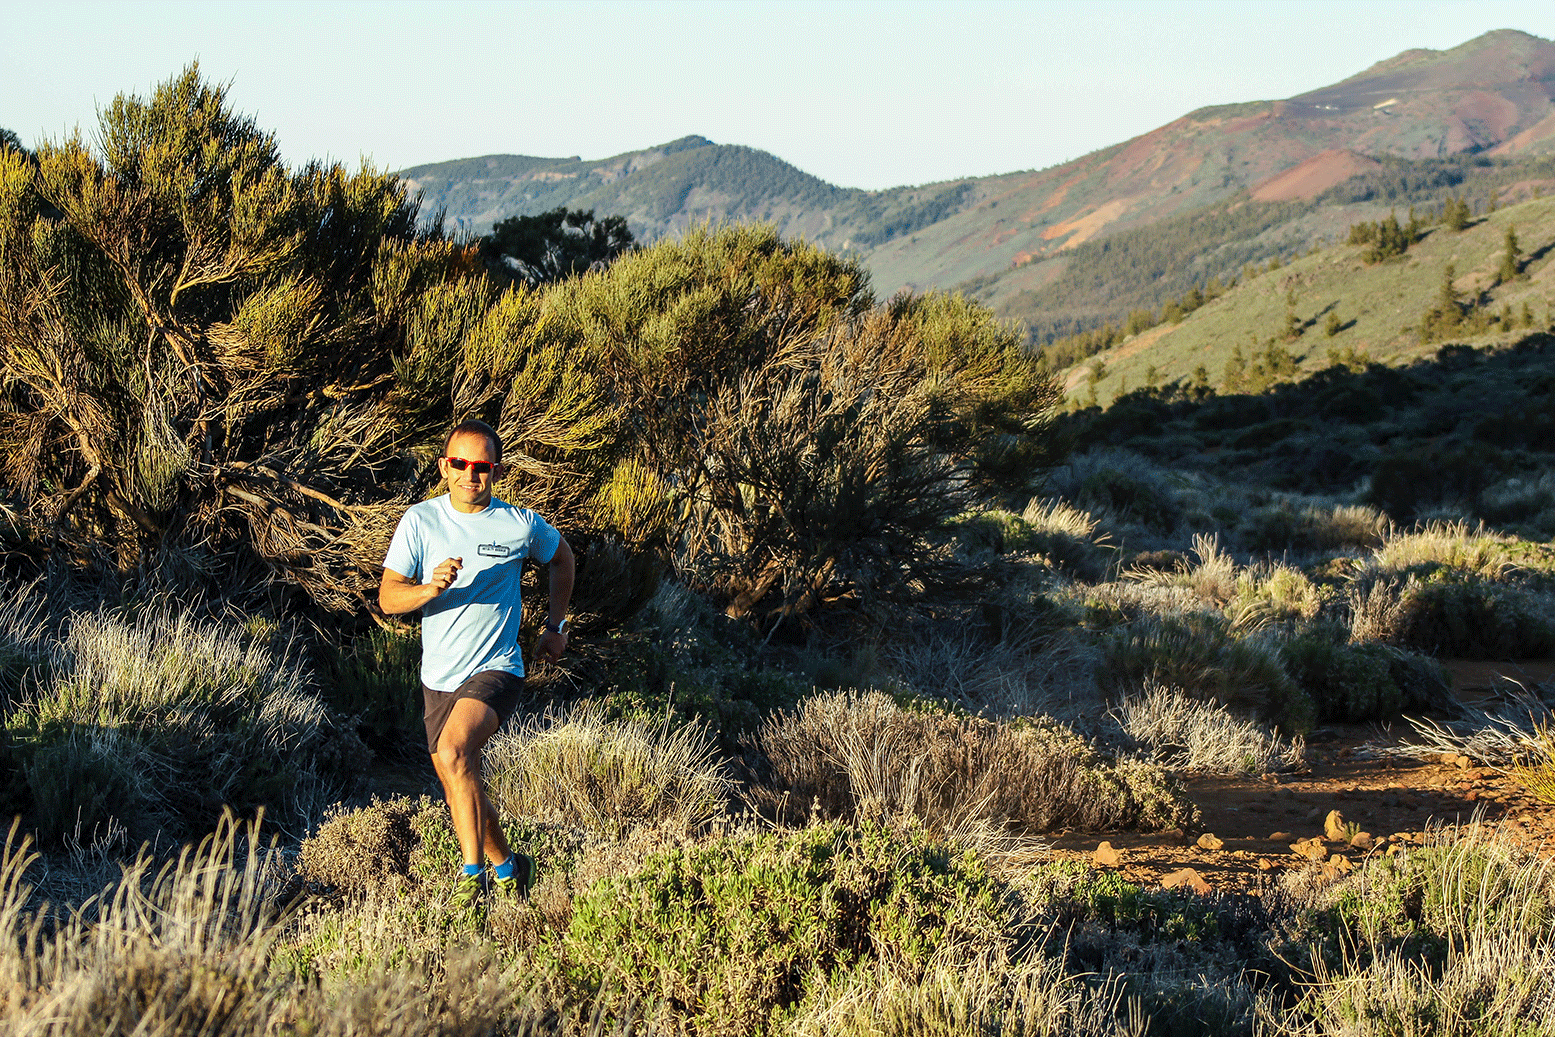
xmin=404 ymin=30 xmax=1555 ymax=340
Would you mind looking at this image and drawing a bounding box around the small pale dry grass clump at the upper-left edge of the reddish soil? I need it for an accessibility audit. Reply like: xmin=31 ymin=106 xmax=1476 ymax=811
xmin=1112 ymin=686 xmax=1306 ymax=774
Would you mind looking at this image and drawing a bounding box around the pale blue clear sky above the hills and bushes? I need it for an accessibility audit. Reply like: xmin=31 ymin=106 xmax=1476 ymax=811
xmin=0 ymin=0 xmax=1555 ymax=188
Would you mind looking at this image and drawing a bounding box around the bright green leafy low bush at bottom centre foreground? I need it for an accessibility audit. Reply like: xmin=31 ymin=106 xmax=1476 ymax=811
xmin=536 ymin=822 xmax=1015 ymax=1037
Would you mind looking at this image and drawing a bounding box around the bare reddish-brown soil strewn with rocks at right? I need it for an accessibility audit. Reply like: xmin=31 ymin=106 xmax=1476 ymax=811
xmin=1050 ymin=661 xmax=1555 ymax=889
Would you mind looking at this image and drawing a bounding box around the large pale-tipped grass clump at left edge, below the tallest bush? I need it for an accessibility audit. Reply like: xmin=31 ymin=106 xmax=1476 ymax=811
xmin=5 ymin=609 xmax=365 ymax=843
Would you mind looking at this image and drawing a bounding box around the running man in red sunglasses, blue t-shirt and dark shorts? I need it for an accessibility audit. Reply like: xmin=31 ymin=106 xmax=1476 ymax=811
xmin=378 ymin=420 xmax=574 ymax=906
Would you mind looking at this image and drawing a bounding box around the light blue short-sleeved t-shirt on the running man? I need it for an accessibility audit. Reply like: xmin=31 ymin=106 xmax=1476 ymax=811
xmin=384 ymin=493 xmax=561 ymax=692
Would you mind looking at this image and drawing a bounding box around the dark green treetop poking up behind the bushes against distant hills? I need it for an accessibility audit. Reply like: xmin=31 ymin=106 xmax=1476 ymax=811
xmin=480 ymin=207 xmax=636 ymax=288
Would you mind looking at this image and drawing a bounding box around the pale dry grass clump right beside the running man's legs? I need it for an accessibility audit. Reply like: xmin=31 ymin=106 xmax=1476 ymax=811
xmin=485 ymin=703 xmax=732 ymax=836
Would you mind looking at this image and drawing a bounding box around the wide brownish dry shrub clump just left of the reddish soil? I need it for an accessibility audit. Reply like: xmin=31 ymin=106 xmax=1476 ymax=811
xmin=756 ymin=690 xmax=1196 ymax=844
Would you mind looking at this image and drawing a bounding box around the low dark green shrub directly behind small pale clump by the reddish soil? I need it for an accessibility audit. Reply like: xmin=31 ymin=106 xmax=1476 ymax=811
xmin=1096 ymin=613 xmax=1317 ymax=734
